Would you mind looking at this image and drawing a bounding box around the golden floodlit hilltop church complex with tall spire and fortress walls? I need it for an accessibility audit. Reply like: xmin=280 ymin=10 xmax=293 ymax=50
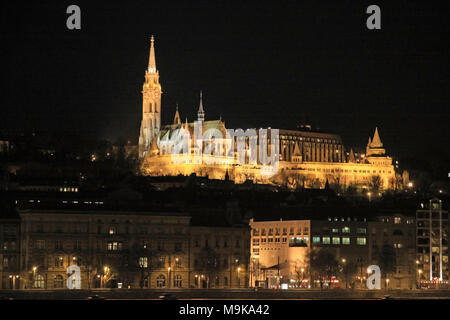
xmin=139 ymin=37 xmax=396 ymax=191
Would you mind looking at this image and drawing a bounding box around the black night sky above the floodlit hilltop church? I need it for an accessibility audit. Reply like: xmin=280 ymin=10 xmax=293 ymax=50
xmin=0 ymin=0 xmax=450 ymax=160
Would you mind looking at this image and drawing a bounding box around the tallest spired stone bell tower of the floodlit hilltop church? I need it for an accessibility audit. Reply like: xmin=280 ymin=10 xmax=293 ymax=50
xmin=139 ymin=36 xmax=162 ymax=158
